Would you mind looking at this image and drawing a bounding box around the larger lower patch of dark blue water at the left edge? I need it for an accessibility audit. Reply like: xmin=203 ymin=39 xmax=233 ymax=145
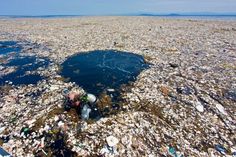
xmin=0 ymin=56 xmax=50 ymax=85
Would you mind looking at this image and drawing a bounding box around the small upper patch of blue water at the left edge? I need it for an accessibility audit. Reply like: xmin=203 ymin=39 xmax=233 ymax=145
xmin=0 ymin=41 xmax=22 ymax=55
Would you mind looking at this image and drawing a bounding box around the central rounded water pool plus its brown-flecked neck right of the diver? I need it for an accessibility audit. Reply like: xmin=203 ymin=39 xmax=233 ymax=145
xmin=60 ymin=50 xmax=149 ymax=120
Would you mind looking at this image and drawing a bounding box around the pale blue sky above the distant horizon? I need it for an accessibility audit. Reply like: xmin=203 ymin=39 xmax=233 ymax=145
xmin=0 ymin=0 xmax=236 ymax=15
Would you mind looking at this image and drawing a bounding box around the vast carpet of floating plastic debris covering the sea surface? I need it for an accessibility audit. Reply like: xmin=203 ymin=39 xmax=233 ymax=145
xmin=0 ymin=17 xmax=236 ymax=156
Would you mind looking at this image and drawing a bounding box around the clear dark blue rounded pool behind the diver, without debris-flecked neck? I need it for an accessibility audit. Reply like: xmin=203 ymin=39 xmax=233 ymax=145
xmin=61 ymin=50 xmax=148 ymax=96
